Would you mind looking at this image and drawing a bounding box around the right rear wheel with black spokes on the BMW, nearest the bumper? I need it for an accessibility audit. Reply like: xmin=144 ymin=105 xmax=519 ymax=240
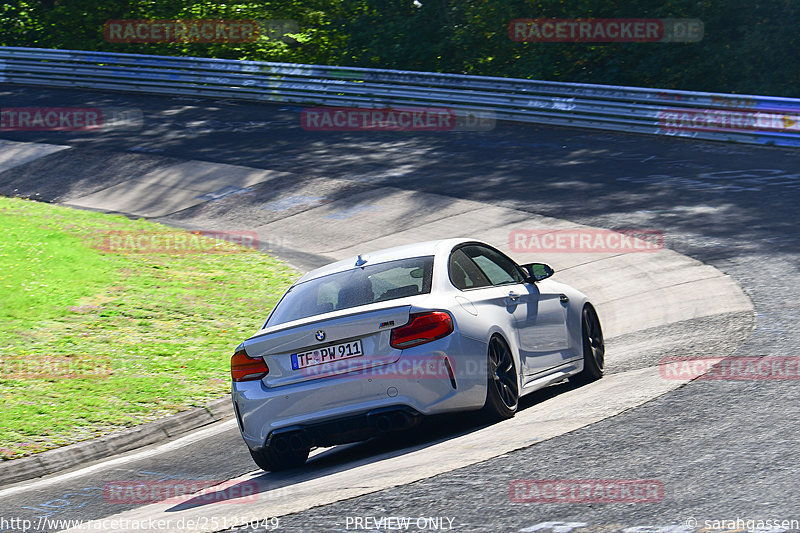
xmin=483 ymin=335 xmax=519 ymax=420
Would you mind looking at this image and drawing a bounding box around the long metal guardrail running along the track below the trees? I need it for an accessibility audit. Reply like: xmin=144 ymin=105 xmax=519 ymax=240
xmin=0 ymin=47 xmax=800 ymax=146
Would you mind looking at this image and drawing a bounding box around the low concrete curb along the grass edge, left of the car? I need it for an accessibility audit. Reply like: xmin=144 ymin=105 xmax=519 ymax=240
xmin=0 ymin=395 xmax=233 ymax=485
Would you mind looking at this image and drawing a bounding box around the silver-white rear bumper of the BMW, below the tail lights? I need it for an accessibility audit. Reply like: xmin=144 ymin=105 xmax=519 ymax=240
xmin=232 ymin=335 xmax=486 ymax=450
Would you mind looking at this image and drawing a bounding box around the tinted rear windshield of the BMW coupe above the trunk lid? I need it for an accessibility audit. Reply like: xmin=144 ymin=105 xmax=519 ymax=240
xmin=265 ymin=256 xmax=433 ymax=327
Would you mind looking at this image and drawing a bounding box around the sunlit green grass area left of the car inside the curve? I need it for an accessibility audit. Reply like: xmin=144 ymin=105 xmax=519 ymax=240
xmin=0 ymin=197 xmax=297 ymax=459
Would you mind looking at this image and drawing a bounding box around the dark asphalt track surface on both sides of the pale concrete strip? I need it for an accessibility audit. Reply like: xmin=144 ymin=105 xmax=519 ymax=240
xmin=0 ymin=86 xmax=800 ymax=533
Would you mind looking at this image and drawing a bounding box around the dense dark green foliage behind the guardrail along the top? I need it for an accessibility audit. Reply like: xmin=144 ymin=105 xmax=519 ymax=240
xmin=0 ymin=0 xmax=800 ymax=96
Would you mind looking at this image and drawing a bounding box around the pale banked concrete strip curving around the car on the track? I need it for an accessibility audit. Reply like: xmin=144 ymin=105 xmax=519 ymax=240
xmin=0 ymin=142 xmax=754 ymax=531
